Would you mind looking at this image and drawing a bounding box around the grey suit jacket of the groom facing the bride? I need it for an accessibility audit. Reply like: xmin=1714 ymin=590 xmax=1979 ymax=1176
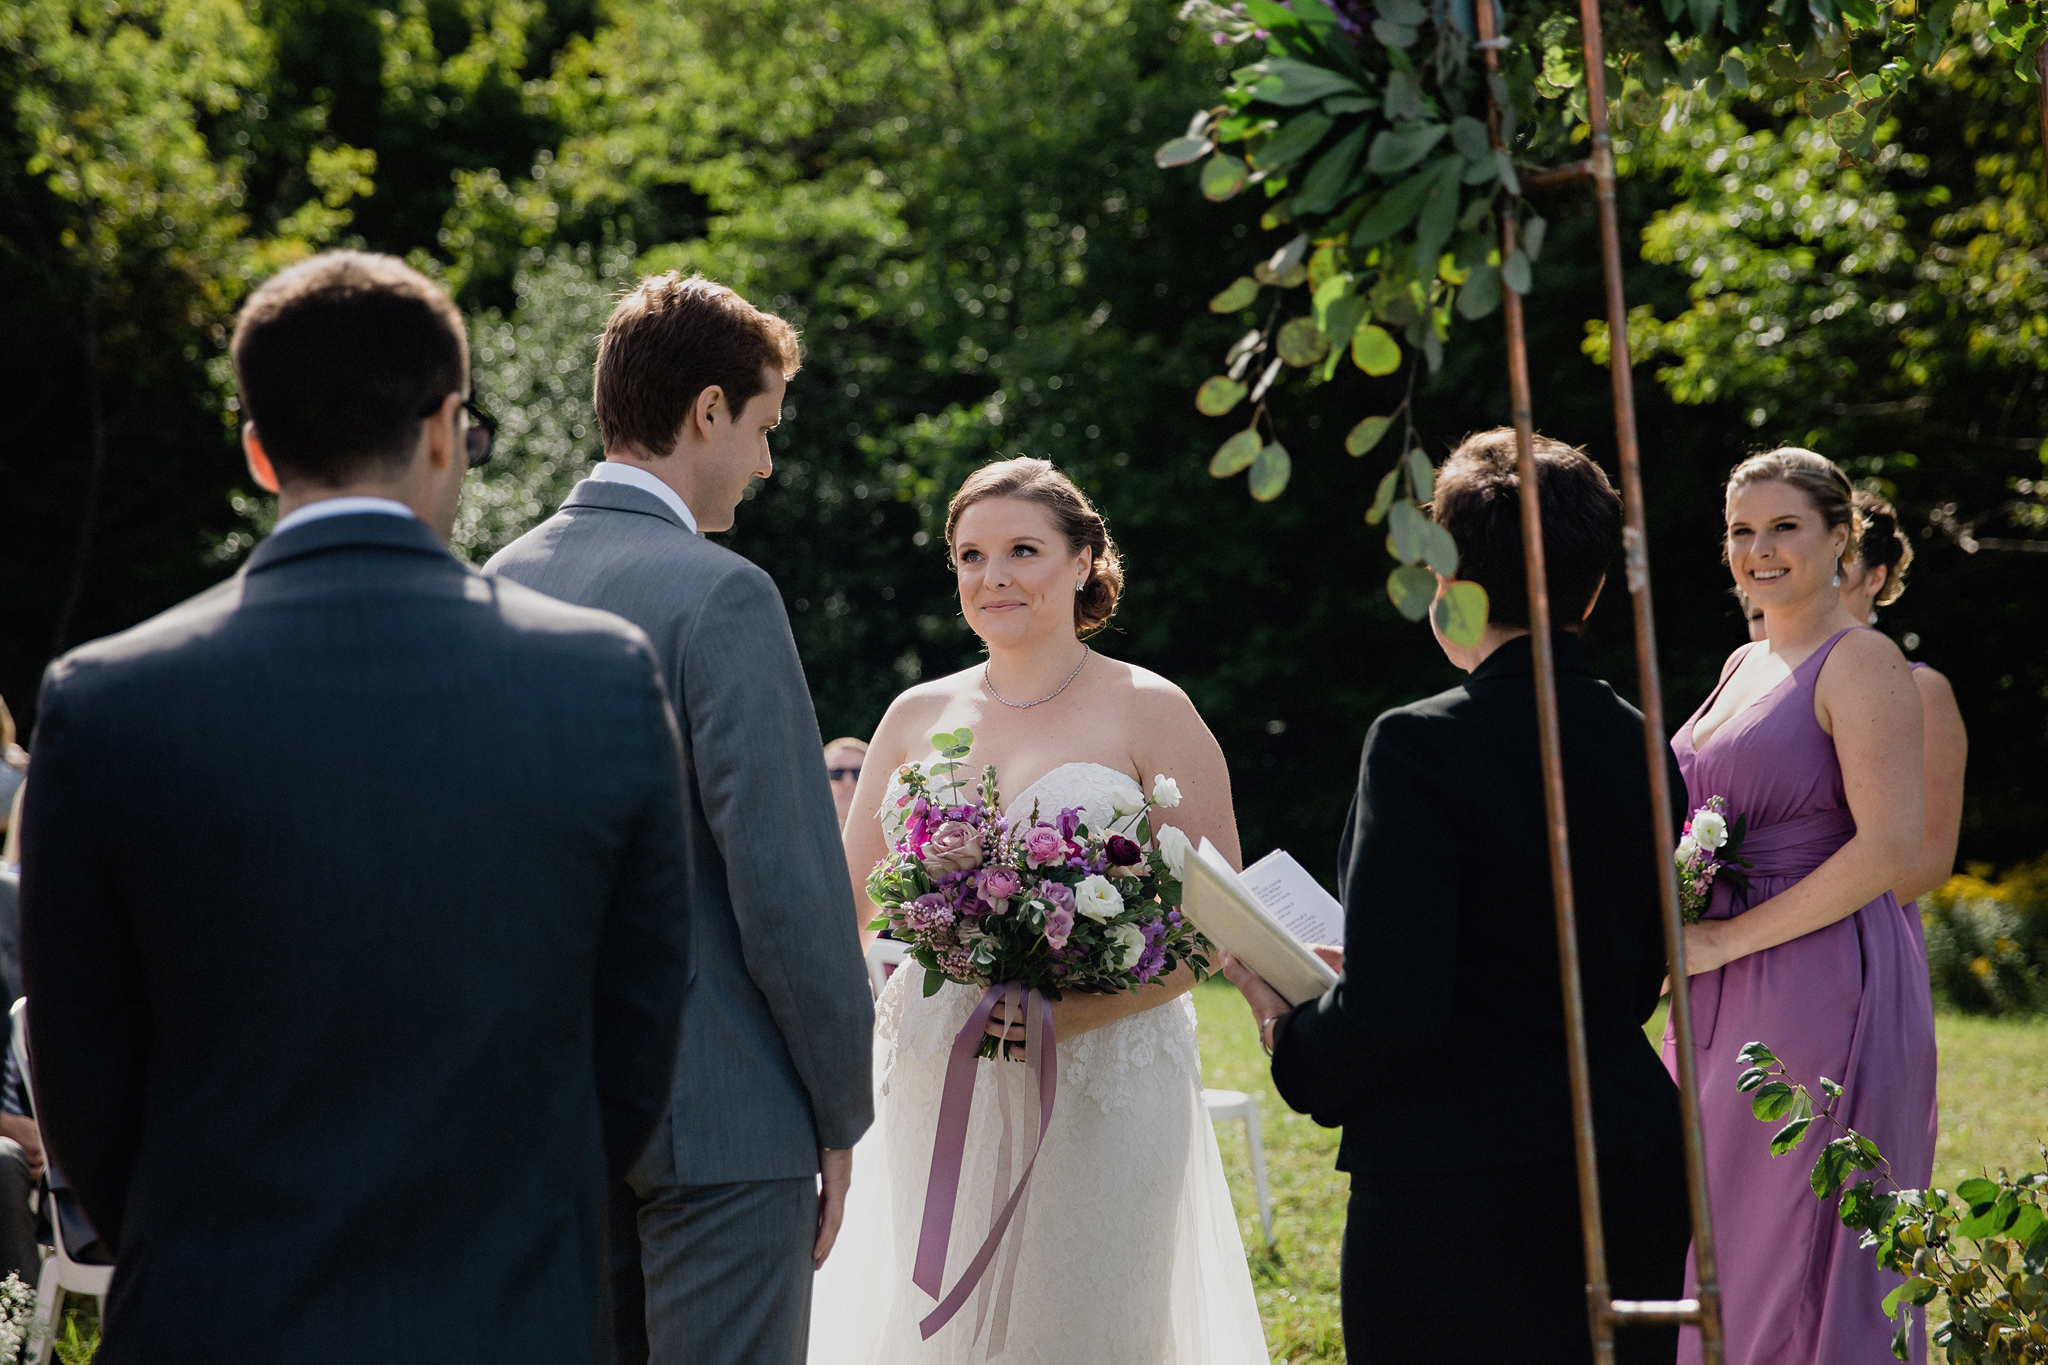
xmin=495 ymin=479 xmax=874 ymax=1185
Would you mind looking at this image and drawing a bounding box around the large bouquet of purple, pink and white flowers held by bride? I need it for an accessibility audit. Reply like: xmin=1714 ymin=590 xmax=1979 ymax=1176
xmin=868 ymin=729 xmax=1208 ymax=1056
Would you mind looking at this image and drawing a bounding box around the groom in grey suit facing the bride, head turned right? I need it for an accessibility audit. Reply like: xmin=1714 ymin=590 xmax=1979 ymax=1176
xmin=485 ymin=272 xmax=874 ymax=1365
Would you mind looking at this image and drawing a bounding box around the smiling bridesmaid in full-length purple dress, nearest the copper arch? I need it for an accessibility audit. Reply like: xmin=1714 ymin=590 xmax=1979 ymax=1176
xmin=1665 ymin=450 xmax=1935 ymax=1365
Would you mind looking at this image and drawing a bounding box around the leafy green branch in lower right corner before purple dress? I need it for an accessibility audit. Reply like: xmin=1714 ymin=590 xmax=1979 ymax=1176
xmin=1735 ymin=1042 xmax=2048 ymax=1365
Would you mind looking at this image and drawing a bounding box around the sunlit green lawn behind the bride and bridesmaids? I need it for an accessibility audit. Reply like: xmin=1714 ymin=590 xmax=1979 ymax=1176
xmin=1194 ymin=980 xmax=2048 ymax=1365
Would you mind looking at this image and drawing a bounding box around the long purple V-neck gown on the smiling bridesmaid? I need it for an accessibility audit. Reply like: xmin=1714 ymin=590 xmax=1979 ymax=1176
xmin=1663 ymin=630 xmax=1935 ymax=1365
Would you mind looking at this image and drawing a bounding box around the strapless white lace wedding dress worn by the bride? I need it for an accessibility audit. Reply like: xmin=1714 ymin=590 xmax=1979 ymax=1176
xmin=809 ymin=763 xmax=1268 ymax=1365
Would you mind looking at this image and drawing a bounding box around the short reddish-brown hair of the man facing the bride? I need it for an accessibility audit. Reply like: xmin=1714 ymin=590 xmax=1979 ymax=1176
xmin=592 ymin=270 xmax=803 ymax=458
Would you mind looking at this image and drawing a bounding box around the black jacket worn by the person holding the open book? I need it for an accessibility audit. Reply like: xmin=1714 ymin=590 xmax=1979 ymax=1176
xmin=1274 ymin=634 xmax=1683 ymax=1173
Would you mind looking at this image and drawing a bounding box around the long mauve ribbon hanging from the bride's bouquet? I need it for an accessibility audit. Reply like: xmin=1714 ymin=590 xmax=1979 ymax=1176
xmin=909 ymin=982 xmax=1059 ymax=1340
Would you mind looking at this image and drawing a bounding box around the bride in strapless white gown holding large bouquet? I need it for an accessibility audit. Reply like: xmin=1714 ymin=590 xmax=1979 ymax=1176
xmin=809 ymin=460 xmax=1268 ymax=1365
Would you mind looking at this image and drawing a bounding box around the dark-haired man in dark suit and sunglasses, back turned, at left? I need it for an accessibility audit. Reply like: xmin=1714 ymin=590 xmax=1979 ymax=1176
xmin=20 ymin=252 xmax=690 ymax=1365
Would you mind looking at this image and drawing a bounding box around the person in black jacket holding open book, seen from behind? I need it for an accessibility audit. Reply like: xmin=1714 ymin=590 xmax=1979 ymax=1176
xmin=1227 ymin=430 xmax=1692 ymax=1365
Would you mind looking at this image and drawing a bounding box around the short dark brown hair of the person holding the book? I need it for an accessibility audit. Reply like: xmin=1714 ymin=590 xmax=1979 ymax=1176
xmin=1430 ymin=426 xmax=1622 ymax=632
